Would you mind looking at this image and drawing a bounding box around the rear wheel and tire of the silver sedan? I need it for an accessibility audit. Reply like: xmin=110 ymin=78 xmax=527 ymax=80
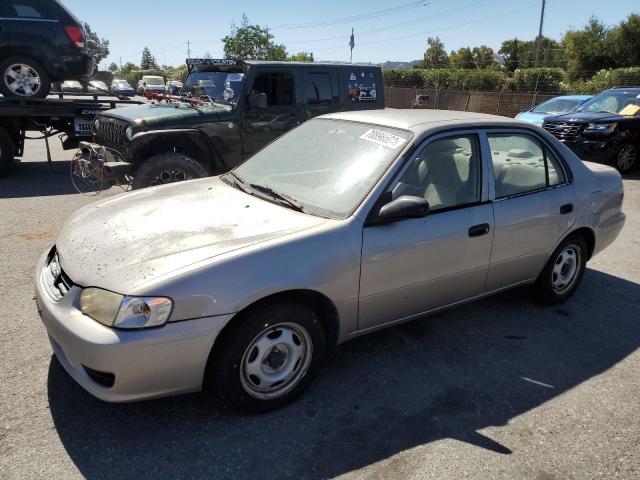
xmin=535 ymin=235 xmax=589 ymax=305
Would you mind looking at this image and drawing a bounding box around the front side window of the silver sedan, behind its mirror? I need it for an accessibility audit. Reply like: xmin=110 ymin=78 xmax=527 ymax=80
xmin=392 ymin=135 xmax=481 ymax=211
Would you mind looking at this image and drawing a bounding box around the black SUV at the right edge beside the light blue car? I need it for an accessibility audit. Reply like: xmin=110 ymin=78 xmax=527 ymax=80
xmin=542 ymin=87 xmax=640 ymax=173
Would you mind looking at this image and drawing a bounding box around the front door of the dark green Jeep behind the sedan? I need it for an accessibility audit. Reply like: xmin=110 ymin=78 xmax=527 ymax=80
xmin=242 ymin=69 xmax=301 ymax=158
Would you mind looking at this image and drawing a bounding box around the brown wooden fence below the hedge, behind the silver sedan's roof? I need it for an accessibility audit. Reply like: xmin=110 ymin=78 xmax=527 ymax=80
xmin=384 ymin=87 xmax=556 ymax=117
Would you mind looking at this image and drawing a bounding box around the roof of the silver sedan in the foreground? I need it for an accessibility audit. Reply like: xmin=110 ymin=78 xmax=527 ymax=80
xmin=321 ymin=108 xmax=530 ymax=133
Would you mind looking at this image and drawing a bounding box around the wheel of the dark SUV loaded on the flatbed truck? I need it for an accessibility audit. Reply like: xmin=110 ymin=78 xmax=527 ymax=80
xmin=0 ymin=56 xmax=51 ymax=98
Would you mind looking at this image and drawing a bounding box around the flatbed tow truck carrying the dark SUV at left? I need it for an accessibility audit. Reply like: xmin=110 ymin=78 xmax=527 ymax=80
xmin=0 ymin=93 xmax=142 ymax=177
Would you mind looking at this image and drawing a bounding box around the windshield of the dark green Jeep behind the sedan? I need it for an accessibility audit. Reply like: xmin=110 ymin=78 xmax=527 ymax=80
xmin=182 ymin=71 xmax=245 ymax=107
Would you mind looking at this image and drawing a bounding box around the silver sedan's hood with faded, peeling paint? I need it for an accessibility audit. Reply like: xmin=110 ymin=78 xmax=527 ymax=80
xmin=56 ymin=177 xmax=326 ymax=294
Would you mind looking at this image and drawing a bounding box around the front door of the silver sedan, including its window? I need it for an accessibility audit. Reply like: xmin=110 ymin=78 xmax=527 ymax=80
xmin=359 ymin=133 xmax=493 ymax=330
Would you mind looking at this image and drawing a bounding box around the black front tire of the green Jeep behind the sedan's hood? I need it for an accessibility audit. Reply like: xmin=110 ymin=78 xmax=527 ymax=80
xmin=133 ymin=152 xmax=209 ymax=190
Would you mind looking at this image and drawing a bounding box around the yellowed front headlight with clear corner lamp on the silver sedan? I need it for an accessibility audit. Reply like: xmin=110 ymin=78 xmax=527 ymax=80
xmin=80 ymin=287 xmax=173 ymax=328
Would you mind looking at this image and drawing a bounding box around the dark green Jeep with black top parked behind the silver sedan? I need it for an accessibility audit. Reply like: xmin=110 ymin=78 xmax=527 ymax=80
xmin=89 ymin=59 xmax=384 ymax=188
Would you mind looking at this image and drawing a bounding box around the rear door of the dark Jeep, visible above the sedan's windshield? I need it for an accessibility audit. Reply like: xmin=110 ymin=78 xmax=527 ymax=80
xmin=298 ymin=69 xmax=342 ymax=120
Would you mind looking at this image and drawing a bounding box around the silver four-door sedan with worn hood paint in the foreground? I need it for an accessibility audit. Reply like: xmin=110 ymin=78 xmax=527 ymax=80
xmin=36 ymin=110 xmax=625 ymax=411
